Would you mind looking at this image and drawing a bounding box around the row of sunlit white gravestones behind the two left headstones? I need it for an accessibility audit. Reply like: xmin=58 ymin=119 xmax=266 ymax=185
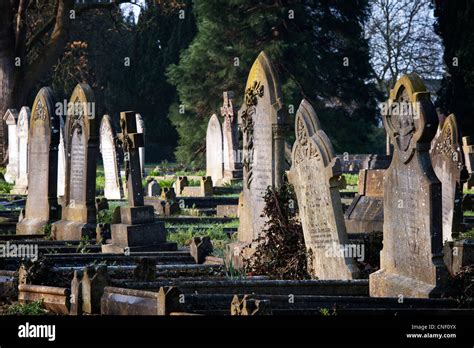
xmin=3 ymin=99 xmax=145 ymax=199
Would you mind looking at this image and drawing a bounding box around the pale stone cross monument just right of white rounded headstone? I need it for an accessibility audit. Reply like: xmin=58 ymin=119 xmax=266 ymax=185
xmin=221 ymin=92 xmax=242 ymax=182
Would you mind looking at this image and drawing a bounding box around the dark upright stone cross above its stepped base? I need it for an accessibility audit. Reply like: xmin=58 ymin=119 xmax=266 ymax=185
xmin=119 ymin=111 xmax=144 ymax=207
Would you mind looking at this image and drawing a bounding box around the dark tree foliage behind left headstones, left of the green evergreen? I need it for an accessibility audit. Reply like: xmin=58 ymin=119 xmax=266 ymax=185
xmin=53 ymin=0 xmax=196 ymax=162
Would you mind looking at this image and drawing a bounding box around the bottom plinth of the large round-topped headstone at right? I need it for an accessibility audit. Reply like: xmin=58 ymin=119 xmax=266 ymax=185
xmin=369 ymin=270 xmax=447 ymax=298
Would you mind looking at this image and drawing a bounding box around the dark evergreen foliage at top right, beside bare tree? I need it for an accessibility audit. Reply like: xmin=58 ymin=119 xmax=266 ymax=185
xmin=435 ymin=0 xmax=474 ymax=136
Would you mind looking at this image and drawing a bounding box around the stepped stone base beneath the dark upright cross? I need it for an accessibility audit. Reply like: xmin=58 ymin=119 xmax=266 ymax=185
xmin=102 ymin=205 xmax=177 ymax=254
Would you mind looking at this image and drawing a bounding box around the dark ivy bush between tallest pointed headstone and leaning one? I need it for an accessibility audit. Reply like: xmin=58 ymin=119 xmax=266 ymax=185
xmin=244 ymin=176 xmax=310 ymax=279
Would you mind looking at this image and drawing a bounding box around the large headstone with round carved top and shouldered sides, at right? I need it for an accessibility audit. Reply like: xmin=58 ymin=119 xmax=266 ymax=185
xmin=369 ymin=74 xmax=447 ymax=299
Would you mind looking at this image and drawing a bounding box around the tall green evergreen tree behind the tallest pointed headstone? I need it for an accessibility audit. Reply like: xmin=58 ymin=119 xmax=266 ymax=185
xmin=168 ymin=0 xmax=381 ymax=167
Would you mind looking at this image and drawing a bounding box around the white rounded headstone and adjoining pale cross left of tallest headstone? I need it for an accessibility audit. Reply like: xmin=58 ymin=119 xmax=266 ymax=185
xmin=206 ymin=92 xmax=242 ymax=186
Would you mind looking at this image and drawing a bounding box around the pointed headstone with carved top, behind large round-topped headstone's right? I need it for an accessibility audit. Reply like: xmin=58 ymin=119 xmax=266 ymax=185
xmin=431 ymin=114 xmax=468 ymax=242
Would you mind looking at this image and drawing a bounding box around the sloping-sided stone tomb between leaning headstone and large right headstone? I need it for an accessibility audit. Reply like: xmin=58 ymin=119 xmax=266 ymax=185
xmin=345 ymin=169 xmax=385 ymax=233
